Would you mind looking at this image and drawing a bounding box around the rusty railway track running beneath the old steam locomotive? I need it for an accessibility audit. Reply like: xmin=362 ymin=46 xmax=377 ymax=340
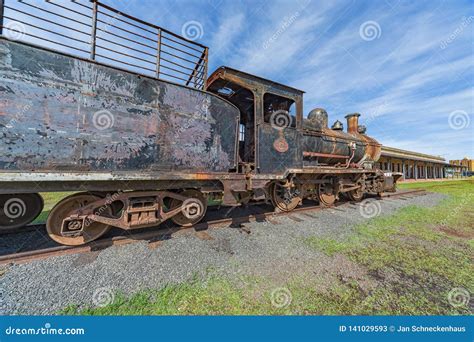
xmin=0 ymin=189 xmax=426 ymax=265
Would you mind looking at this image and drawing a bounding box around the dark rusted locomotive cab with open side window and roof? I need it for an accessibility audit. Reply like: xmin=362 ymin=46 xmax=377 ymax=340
xmin=206 ymin=67 xmax=304 ymax=173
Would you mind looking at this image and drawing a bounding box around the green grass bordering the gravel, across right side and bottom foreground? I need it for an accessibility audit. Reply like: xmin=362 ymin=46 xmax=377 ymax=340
xmin=63 ymin=180 xmax=474 ymax=315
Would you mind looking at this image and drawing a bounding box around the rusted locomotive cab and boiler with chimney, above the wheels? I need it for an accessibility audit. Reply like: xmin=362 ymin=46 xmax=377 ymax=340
xmin=207 ymin=67 xmax=380 ymax=173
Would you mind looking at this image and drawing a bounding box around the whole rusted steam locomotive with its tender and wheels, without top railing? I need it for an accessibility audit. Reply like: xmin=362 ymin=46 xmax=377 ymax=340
xmin=0 ymin=10 xmax=396 ymax=245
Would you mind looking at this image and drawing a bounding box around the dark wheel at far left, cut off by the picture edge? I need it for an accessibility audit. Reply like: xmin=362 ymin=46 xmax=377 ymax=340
xmin=0 ymin=194 xmax=44 ymax=231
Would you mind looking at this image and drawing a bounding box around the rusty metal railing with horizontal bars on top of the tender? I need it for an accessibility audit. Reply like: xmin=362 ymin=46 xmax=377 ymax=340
xmin=0 ymin=0 xmax=209 ymax=89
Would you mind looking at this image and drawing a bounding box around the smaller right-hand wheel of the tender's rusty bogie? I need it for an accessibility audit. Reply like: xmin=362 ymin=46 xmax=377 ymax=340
xmin=170 ymin=189 xmax=207 ymax=227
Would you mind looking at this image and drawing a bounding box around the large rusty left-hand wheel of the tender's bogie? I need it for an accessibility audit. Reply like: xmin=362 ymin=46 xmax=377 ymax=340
xmin=46 ymin=193 xmax=112 ymax=246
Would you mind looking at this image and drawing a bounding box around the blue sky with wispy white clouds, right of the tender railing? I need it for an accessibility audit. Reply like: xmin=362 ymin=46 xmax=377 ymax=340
xmin=5 ymin=0 xmax=474 ymax=159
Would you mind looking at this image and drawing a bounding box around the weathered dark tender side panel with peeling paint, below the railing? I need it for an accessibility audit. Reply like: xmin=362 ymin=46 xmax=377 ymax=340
xmin=0 ymin=39 xmax=239 ymax=172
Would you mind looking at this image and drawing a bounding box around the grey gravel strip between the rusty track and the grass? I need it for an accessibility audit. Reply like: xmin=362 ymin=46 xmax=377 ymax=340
xmin=0 ymin=193 xmax=445 ymax=315
